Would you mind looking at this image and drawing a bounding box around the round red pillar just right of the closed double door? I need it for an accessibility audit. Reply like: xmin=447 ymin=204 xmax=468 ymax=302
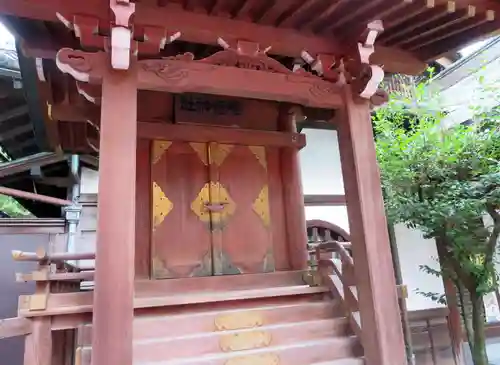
xmin=279 ymin=105 xmax=309 ymax=270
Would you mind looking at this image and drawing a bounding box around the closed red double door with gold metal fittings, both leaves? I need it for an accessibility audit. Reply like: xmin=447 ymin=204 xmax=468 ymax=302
xmin=151 ymin=141 xmax=274 ymax=278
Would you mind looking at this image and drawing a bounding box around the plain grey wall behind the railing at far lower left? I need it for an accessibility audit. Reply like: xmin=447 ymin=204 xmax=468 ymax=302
xmin=0 ymin=234 xmax=49 ymax=365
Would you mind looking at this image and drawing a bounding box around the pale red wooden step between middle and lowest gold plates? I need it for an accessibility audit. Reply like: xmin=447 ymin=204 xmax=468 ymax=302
xmin=77 ymin=337 xmax=362 ymax=365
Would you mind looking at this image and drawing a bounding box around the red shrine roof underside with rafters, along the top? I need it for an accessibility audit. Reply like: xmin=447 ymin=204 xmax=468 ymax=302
xmin=0 ymin=0 xmax=500 ymax=74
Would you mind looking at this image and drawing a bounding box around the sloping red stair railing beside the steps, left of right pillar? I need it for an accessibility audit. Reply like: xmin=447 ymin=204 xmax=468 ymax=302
xmin=315 ymin=241 xmax=362 ymax=340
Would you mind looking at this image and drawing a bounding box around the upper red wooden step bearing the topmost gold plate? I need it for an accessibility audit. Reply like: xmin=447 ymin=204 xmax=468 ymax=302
xmin=79 ymin=298 xmax=343 ymax=346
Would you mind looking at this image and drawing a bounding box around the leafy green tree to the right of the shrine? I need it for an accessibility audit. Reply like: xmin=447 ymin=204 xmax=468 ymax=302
xmin=373 ymin=80 xmax=500 ymax=365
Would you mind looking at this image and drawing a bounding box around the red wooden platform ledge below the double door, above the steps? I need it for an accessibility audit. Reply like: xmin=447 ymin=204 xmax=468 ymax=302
xmin=19 ymin=271 xmax=327 ymax=317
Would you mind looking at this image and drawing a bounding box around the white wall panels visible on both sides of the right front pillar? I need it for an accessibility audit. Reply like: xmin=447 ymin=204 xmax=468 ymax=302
xmin=300 ymin=129 xmax=444 ymax=310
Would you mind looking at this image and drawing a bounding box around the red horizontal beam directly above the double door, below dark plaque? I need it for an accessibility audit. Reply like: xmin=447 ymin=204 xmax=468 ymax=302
xmin=137 ymin=122 xmax=306 ymax=148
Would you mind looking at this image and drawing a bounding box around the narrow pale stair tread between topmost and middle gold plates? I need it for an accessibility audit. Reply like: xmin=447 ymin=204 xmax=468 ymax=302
xmin=134 ymin=317 xmax=348 ymax=345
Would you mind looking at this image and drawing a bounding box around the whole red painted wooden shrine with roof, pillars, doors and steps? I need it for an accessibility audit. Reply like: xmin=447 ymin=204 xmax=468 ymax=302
xmin=0 ymin=0 xmax=500 ymax=365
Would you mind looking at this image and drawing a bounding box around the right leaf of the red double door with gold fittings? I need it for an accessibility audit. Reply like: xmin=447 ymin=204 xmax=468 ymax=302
xmin=215 ymin=145 xmax=274 ymax=274
